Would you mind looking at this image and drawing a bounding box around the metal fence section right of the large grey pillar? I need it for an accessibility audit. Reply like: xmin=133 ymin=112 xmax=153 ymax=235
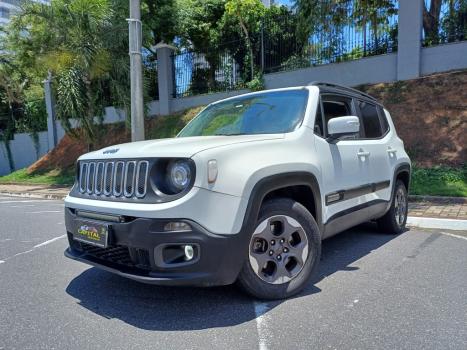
xmin=422 ymin=0 xmax=467 ymax=46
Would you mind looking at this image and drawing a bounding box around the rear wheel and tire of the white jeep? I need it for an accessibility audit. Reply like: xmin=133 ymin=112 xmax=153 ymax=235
xmin=377 ymin=180 xmax=408 ymax=234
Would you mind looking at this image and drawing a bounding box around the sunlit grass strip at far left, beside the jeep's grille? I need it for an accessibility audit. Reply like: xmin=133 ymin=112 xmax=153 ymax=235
xmin=0 ymin=169 xmax=75 ymax=185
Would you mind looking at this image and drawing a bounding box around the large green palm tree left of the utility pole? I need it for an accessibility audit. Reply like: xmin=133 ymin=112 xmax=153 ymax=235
xmin=7 ymin=0 xmax=129 ymax=147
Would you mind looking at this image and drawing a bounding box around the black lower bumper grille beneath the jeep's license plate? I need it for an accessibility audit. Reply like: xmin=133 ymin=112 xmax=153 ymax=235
xmin=73 ymin=241 xmax=151 ymax=269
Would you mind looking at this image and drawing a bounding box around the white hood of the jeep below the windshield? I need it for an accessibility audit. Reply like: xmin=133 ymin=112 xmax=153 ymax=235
xmin=79 ymin=134 xmax=284 ymax=160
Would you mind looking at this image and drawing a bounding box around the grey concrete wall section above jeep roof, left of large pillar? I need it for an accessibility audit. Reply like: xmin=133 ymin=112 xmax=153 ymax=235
xmin=264 ymin=53 xmax=397 ymax=89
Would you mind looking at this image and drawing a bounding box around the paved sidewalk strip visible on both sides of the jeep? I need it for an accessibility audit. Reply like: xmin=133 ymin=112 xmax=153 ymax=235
xmin=0 ymin=184 xmax=467 ymax=220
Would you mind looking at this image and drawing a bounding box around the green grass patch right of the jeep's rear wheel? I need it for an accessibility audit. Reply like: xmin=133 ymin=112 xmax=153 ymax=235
xmin=410 ymin=165 xmax=467 ymax=197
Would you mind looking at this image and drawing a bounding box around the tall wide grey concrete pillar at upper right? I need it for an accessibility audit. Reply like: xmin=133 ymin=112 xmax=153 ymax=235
xmin=397 ymin=0 xmax=424 ymax=80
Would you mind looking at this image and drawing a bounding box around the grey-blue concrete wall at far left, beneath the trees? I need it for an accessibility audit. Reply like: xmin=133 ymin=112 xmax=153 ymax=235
xmin=0 ymin=131 xmax=49 ymax=176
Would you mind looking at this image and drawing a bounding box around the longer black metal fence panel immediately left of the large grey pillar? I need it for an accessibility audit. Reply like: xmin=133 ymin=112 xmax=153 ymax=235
xmin=263 ymin=1 xmax=398 ymax=73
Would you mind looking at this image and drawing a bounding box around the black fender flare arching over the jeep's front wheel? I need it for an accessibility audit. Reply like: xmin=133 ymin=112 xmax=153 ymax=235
xmin=242 ymin=172 xmax=323 ymax=234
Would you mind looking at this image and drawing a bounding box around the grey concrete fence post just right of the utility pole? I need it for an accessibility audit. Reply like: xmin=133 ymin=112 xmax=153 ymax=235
xmin=155 ymin=42 xmax=175 ymax=115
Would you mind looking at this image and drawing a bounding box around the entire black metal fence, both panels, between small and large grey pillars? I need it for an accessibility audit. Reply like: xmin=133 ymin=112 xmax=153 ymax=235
xmin=172 ymin=0 xmax=398 ymax=97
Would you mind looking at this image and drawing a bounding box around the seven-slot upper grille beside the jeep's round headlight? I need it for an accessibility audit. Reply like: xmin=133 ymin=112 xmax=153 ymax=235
xmin=78 ymin=160 xmax=149 ymax=198
